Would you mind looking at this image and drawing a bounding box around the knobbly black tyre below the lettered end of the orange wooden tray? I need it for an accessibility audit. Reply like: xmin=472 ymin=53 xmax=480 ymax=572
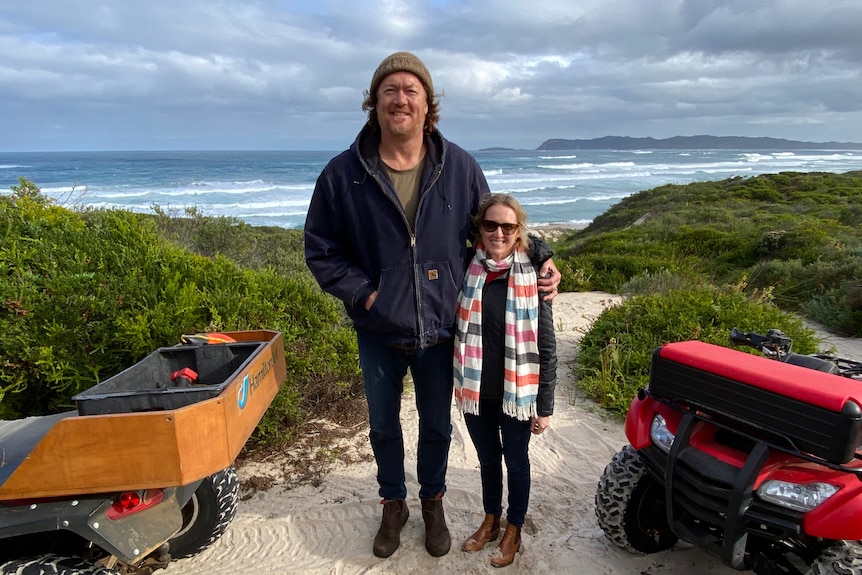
xmin=168 ymin=467 xmax=239 ymax=559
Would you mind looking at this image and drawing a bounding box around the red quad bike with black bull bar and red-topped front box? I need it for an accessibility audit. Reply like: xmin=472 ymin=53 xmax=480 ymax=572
xmin=596 ymin=328 xmax=862 ymax=575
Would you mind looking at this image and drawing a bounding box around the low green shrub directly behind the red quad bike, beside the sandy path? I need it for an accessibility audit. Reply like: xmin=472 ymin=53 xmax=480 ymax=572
xmin=574 ymin=286 xmax=816 ymax=415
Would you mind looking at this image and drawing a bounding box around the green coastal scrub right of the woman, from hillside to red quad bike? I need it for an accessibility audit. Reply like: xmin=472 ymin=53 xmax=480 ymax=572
xmin=555 ymin=172 xmax=862 ymax=414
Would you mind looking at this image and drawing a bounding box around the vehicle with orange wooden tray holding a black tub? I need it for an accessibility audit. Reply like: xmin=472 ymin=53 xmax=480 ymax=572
xmin=0 ymin=330 xmax=286 ymax=575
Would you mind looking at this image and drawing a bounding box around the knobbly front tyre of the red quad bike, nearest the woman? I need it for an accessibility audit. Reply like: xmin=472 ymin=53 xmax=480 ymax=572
xmin=596 ymin=445 xmax=678 ymax=553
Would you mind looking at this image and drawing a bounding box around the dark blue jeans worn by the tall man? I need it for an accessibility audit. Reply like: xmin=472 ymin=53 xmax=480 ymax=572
xmin=357 ymin=332 xmax=453 ymax=499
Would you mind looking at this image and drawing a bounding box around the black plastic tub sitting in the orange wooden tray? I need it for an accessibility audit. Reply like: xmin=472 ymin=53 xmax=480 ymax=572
xmin=72 ymin=342 xmax=266 ymax=415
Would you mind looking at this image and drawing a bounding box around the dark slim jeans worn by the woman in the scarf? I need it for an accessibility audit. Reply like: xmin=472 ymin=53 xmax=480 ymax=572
xmin=464 ymin=401 xmax=530 ymax=527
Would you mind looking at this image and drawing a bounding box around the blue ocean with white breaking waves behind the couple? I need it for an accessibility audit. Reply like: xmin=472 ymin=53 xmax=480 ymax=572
xmin=0 ymin=150 xmax=862 ymax=228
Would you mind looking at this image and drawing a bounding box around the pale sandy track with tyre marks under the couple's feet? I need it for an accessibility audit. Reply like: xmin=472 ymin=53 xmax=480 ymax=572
xmin=159 ymin=292 xmax=862 ymax=575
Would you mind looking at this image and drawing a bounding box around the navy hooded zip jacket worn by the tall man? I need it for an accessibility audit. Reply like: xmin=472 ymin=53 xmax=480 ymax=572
xmin=305 ymin=125 xmax=490 ymax=348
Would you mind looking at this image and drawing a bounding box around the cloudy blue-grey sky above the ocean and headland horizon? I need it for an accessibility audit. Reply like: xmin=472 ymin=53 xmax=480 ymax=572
xmin=0 ymin=0 xmax=862 ymax=151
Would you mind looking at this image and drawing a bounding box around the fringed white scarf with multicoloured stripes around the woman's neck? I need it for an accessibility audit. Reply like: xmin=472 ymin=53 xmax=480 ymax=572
xmin=453 ymin=244 xmax=539 ymax=421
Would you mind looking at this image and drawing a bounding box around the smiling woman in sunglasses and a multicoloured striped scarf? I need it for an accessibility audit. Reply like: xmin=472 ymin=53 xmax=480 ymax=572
xmin=454 ymin=194 xmax=557 ymax=567
